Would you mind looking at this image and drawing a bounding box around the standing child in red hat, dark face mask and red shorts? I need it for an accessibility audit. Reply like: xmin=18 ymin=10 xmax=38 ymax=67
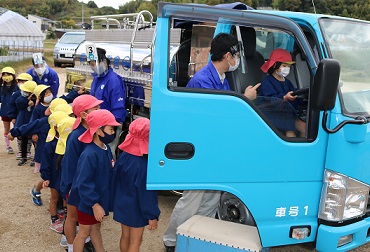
xmin=67 ymin=109 xmax=119 ymax=252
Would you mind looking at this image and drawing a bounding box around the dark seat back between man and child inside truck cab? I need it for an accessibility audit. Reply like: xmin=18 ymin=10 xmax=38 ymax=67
xmin=226 ymin=26 xmax=265 ymax=93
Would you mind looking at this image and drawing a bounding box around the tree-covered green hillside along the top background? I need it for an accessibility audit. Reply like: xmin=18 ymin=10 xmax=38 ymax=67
xmin=0 ymin=0 xmax=370 ymax=27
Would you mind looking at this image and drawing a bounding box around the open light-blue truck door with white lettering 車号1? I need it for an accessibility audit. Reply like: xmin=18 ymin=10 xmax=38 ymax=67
xmin=147 ymin=3 xmax=327 ymax=247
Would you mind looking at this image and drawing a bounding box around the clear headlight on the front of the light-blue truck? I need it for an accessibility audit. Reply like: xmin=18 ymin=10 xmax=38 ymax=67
xmin=319 ymin=170 xmax=370 ymax=222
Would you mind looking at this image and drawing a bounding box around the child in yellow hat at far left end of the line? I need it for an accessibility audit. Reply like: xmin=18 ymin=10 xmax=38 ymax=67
xmin=0 ymin=67 xmax=18 ymax=154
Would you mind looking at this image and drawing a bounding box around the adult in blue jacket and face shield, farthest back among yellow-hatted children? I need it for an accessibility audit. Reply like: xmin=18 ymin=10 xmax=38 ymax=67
xmin=27 ymin=57 xmax=59 ymax=97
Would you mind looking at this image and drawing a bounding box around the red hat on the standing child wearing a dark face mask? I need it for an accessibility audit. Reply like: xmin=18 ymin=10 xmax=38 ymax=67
xmin=78 ymin=109 xmax=120 ymax=143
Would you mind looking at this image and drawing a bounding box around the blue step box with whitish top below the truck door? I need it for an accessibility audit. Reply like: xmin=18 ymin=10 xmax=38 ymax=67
xmin=176 ymin=215 xmax=269 ymax=252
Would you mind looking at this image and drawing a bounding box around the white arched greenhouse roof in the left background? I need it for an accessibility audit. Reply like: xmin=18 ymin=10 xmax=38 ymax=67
xmin=0 ymin=7 xmax=43 ymax=38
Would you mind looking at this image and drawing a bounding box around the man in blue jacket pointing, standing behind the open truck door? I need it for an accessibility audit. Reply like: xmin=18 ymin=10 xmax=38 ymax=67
xmin=163 ymin=33 xmax=260 ymax=252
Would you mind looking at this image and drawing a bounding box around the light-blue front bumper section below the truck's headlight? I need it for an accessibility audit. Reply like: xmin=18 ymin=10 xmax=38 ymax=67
xmin=316 ymin=217 xmax=370 ymax=252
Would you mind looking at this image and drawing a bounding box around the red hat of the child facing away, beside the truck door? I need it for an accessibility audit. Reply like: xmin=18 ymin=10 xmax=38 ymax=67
xmin=118 ymin=117 xmax=149 ymax=156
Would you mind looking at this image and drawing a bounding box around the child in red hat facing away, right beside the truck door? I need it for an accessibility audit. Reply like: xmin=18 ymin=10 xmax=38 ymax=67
xmin=111 ymin=118 xmax=160 ymax=252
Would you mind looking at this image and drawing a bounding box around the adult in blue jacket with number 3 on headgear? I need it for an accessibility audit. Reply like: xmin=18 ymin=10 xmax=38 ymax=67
xmin=89 ymin=48 xmax=126 ymax=159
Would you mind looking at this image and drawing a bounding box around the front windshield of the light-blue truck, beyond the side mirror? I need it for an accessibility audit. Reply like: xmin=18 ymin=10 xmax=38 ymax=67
xmin=320 ymin=18 xmax=370 ymax=116
